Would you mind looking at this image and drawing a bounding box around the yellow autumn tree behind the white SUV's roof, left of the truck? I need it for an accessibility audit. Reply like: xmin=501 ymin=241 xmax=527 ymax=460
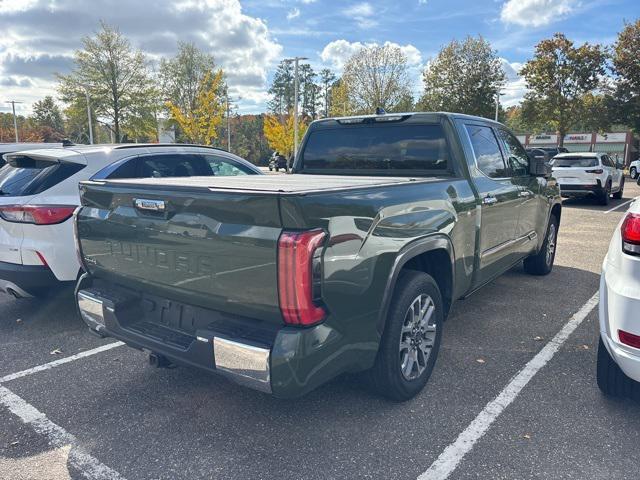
xmin=167 ymin=70 xmax=225 ymax=145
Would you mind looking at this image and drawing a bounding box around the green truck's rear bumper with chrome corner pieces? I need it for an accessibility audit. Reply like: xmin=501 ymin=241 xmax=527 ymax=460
xmin=76 ymin=276 xmax=377 ymax=398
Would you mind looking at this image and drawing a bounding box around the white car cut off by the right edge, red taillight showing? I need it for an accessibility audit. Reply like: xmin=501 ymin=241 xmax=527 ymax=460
xmin=597 ymin=200 xmax=640 ymax=396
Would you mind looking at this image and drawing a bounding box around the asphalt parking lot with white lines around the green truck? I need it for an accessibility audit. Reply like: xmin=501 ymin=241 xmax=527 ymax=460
xmin=0 ymin=182 xmax=640 ymax=480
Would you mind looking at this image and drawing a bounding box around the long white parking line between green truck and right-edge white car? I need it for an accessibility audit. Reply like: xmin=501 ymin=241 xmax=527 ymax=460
xmin=418 ymin=292 xmax=599 ymax=480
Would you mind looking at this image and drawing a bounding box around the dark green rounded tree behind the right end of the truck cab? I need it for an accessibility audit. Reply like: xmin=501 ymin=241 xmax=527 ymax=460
xmin=420 ymin=36 xmax=505 ymax=118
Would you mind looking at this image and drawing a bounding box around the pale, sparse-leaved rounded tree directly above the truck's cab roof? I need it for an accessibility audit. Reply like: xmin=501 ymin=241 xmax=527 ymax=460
xmin=341 ymin=44 xmax=411 ymax=113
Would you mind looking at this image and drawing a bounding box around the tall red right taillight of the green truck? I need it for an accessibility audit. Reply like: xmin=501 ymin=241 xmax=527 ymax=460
xmin=278 ymin=230 xmax=326 ymax=326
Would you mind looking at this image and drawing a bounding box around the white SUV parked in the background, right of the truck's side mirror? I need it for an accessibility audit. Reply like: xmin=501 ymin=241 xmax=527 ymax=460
xmin=551 ymin=153 xmax=624 ymax=205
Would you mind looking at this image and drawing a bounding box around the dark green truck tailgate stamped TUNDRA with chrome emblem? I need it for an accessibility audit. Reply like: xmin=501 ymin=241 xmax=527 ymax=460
xmin=78 ymin=182 xmax=282 ymax=322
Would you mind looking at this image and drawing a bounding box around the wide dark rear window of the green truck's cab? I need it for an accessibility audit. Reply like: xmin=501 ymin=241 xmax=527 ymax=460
xmin=301 ymin=124 xmax=450 ymax=175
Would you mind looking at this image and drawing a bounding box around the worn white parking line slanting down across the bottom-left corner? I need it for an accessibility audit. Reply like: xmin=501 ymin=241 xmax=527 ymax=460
xmin=0 ymin=385 xmax=125 ymax=480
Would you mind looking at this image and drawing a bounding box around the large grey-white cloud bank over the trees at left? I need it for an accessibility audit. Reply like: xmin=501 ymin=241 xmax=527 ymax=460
xmin=0 ymin=0 xmax=282 ymax=110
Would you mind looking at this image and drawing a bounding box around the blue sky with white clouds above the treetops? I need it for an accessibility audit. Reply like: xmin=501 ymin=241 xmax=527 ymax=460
xmin=0 ymin=0 xmax=640 ymax=114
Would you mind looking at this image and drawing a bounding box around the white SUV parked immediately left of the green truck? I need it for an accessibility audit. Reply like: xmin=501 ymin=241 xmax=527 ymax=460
xmin=0 ymin=144 xmax=261 ymax=297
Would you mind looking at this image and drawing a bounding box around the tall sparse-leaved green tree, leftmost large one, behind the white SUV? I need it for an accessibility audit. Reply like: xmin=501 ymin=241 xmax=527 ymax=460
xmin=58 ymin=23 xmax=155 ymax=142
